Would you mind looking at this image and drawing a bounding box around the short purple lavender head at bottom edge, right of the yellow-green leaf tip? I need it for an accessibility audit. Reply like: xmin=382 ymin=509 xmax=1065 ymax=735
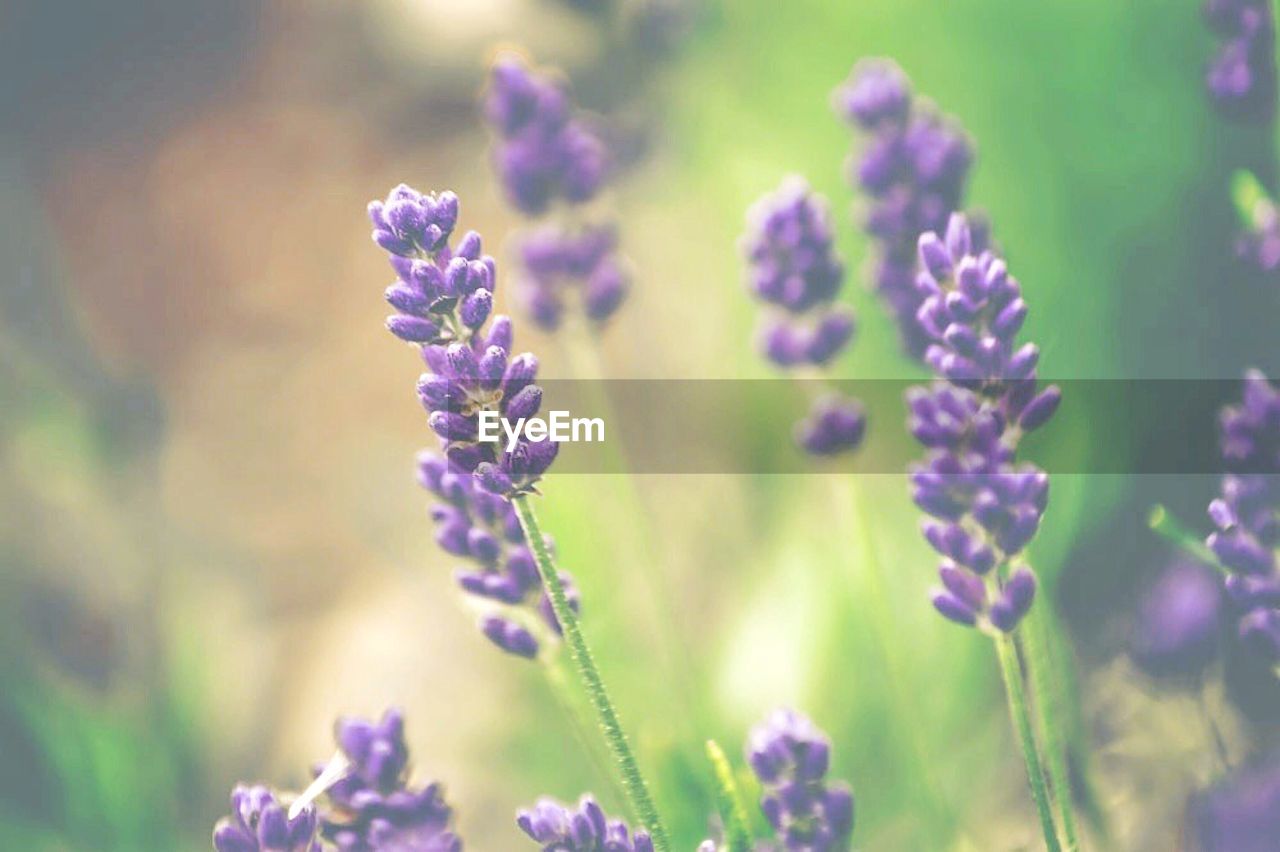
xmin=746 ymin=709 xmax=854 ymax=852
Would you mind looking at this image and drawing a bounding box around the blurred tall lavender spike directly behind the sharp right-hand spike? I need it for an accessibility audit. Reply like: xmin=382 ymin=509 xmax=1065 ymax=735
xmin=833 ymin=59 xmax=986 ymax=357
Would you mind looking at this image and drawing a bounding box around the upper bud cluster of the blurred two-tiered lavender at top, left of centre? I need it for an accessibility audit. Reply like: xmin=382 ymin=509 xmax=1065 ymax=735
xmin=484 ymin=55 xmax=609 ymax=215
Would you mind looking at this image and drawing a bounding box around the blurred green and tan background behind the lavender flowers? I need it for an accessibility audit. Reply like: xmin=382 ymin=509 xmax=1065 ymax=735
xmin=0 ymin=0 xmax=1280 ymax=851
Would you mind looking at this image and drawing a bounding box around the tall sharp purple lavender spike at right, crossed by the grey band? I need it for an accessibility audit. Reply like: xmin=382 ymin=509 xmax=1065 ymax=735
xmin=908 ymin=214 xmax=1061 ymax=633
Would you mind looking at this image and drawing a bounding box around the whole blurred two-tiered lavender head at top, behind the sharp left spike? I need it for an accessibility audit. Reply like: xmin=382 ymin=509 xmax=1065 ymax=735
xmin=484 ymin=55 xmax=630 ymax=330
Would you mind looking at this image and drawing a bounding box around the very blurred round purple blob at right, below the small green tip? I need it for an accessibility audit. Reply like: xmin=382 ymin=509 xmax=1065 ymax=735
xmin=1130 ymin=560 xmax=1222 ymax=679
